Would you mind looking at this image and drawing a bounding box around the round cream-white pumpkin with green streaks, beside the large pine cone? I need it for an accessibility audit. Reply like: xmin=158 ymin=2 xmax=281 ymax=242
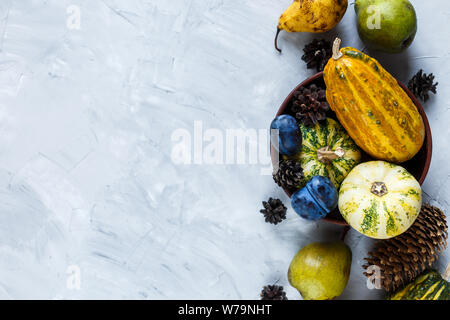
xmin=338 ymin=161 xmax=422 ymax=239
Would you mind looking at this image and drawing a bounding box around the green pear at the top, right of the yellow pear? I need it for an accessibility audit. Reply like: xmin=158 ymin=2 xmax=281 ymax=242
xmin=355 ymin=0 xmax=417 ymax=53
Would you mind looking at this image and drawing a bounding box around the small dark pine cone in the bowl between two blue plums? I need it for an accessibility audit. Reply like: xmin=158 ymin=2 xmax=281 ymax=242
xmin=272 ymin=160 xmax=305 ymax=191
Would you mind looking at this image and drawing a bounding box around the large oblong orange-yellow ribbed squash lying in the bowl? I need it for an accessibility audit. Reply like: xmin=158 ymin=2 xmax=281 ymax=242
xmin=324 ymin=48 xmax=425 ymax=163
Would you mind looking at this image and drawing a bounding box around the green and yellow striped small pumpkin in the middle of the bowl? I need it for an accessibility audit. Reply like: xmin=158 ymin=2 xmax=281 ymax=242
xmin=290 ymin=118 xmax=361 ymax=189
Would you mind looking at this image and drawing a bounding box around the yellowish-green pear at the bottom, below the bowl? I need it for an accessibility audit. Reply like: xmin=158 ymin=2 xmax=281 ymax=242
xmin=288 ymin=241 xmax=352 ymax=300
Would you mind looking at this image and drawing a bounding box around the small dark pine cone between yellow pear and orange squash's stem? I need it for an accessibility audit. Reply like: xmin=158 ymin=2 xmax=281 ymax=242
xmin=302 ymin=39 xmax=332 ymax=72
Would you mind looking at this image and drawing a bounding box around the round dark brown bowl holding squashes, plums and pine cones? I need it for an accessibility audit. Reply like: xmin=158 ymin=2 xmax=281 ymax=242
xmin=271 ymin=72 xmax=432 ymax=226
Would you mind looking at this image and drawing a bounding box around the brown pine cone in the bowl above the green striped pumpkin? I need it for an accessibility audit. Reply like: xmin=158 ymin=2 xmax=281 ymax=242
xmin=291 ymin=84 xmax=330 ymax=126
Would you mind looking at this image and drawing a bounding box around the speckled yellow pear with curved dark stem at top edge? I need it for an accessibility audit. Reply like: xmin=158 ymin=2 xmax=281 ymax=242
xmin=275 ymin=0 xmax=348 ymax=52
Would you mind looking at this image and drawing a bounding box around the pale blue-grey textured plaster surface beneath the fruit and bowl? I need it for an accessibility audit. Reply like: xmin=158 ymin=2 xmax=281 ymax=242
xmin=0 ymin=0 xmax=450 ymax=299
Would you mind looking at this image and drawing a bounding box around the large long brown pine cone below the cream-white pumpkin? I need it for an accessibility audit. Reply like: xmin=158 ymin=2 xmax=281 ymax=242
xmin=363 ymin=204 xmax=448 ymax=292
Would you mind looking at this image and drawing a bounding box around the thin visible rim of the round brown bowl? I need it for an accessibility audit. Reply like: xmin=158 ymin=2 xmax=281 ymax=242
xmin=270 ymin=71 xmax=433 ymax=226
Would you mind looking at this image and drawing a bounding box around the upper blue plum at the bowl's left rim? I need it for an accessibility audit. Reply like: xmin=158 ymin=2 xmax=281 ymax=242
xmin=270 ymin=114 xmax=302 ymax=156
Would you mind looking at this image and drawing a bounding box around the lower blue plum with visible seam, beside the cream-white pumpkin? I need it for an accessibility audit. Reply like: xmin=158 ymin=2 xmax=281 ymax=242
xmin=291 ymin=176 xmax=338 ymax=220
